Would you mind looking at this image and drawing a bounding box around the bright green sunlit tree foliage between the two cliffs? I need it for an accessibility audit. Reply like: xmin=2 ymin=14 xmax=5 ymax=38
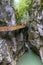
xmin=15 ymin=0 xmax=33 ymax=21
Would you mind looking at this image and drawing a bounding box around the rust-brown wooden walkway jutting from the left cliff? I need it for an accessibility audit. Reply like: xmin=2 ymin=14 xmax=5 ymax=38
xmin=0 ymin=25 xmax=26 ymax=32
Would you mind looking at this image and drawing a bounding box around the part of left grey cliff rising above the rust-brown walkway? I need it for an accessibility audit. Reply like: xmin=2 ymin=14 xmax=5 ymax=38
xmin=0 ymin=0 xmax=16 ymax=26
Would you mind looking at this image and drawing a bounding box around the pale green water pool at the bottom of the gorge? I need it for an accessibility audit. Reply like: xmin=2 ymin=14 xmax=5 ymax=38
xmin=17 ymin=50 xmax=43 ymax=65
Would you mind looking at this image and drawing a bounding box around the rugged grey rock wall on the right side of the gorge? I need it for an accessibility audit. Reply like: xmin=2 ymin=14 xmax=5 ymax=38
xmin=29 ymin=0 xmax=43 ymax=62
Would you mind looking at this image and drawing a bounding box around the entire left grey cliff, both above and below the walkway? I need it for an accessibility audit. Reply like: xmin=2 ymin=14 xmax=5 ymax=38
xmin=0 ymin=0 xmax=28 ymax=65
